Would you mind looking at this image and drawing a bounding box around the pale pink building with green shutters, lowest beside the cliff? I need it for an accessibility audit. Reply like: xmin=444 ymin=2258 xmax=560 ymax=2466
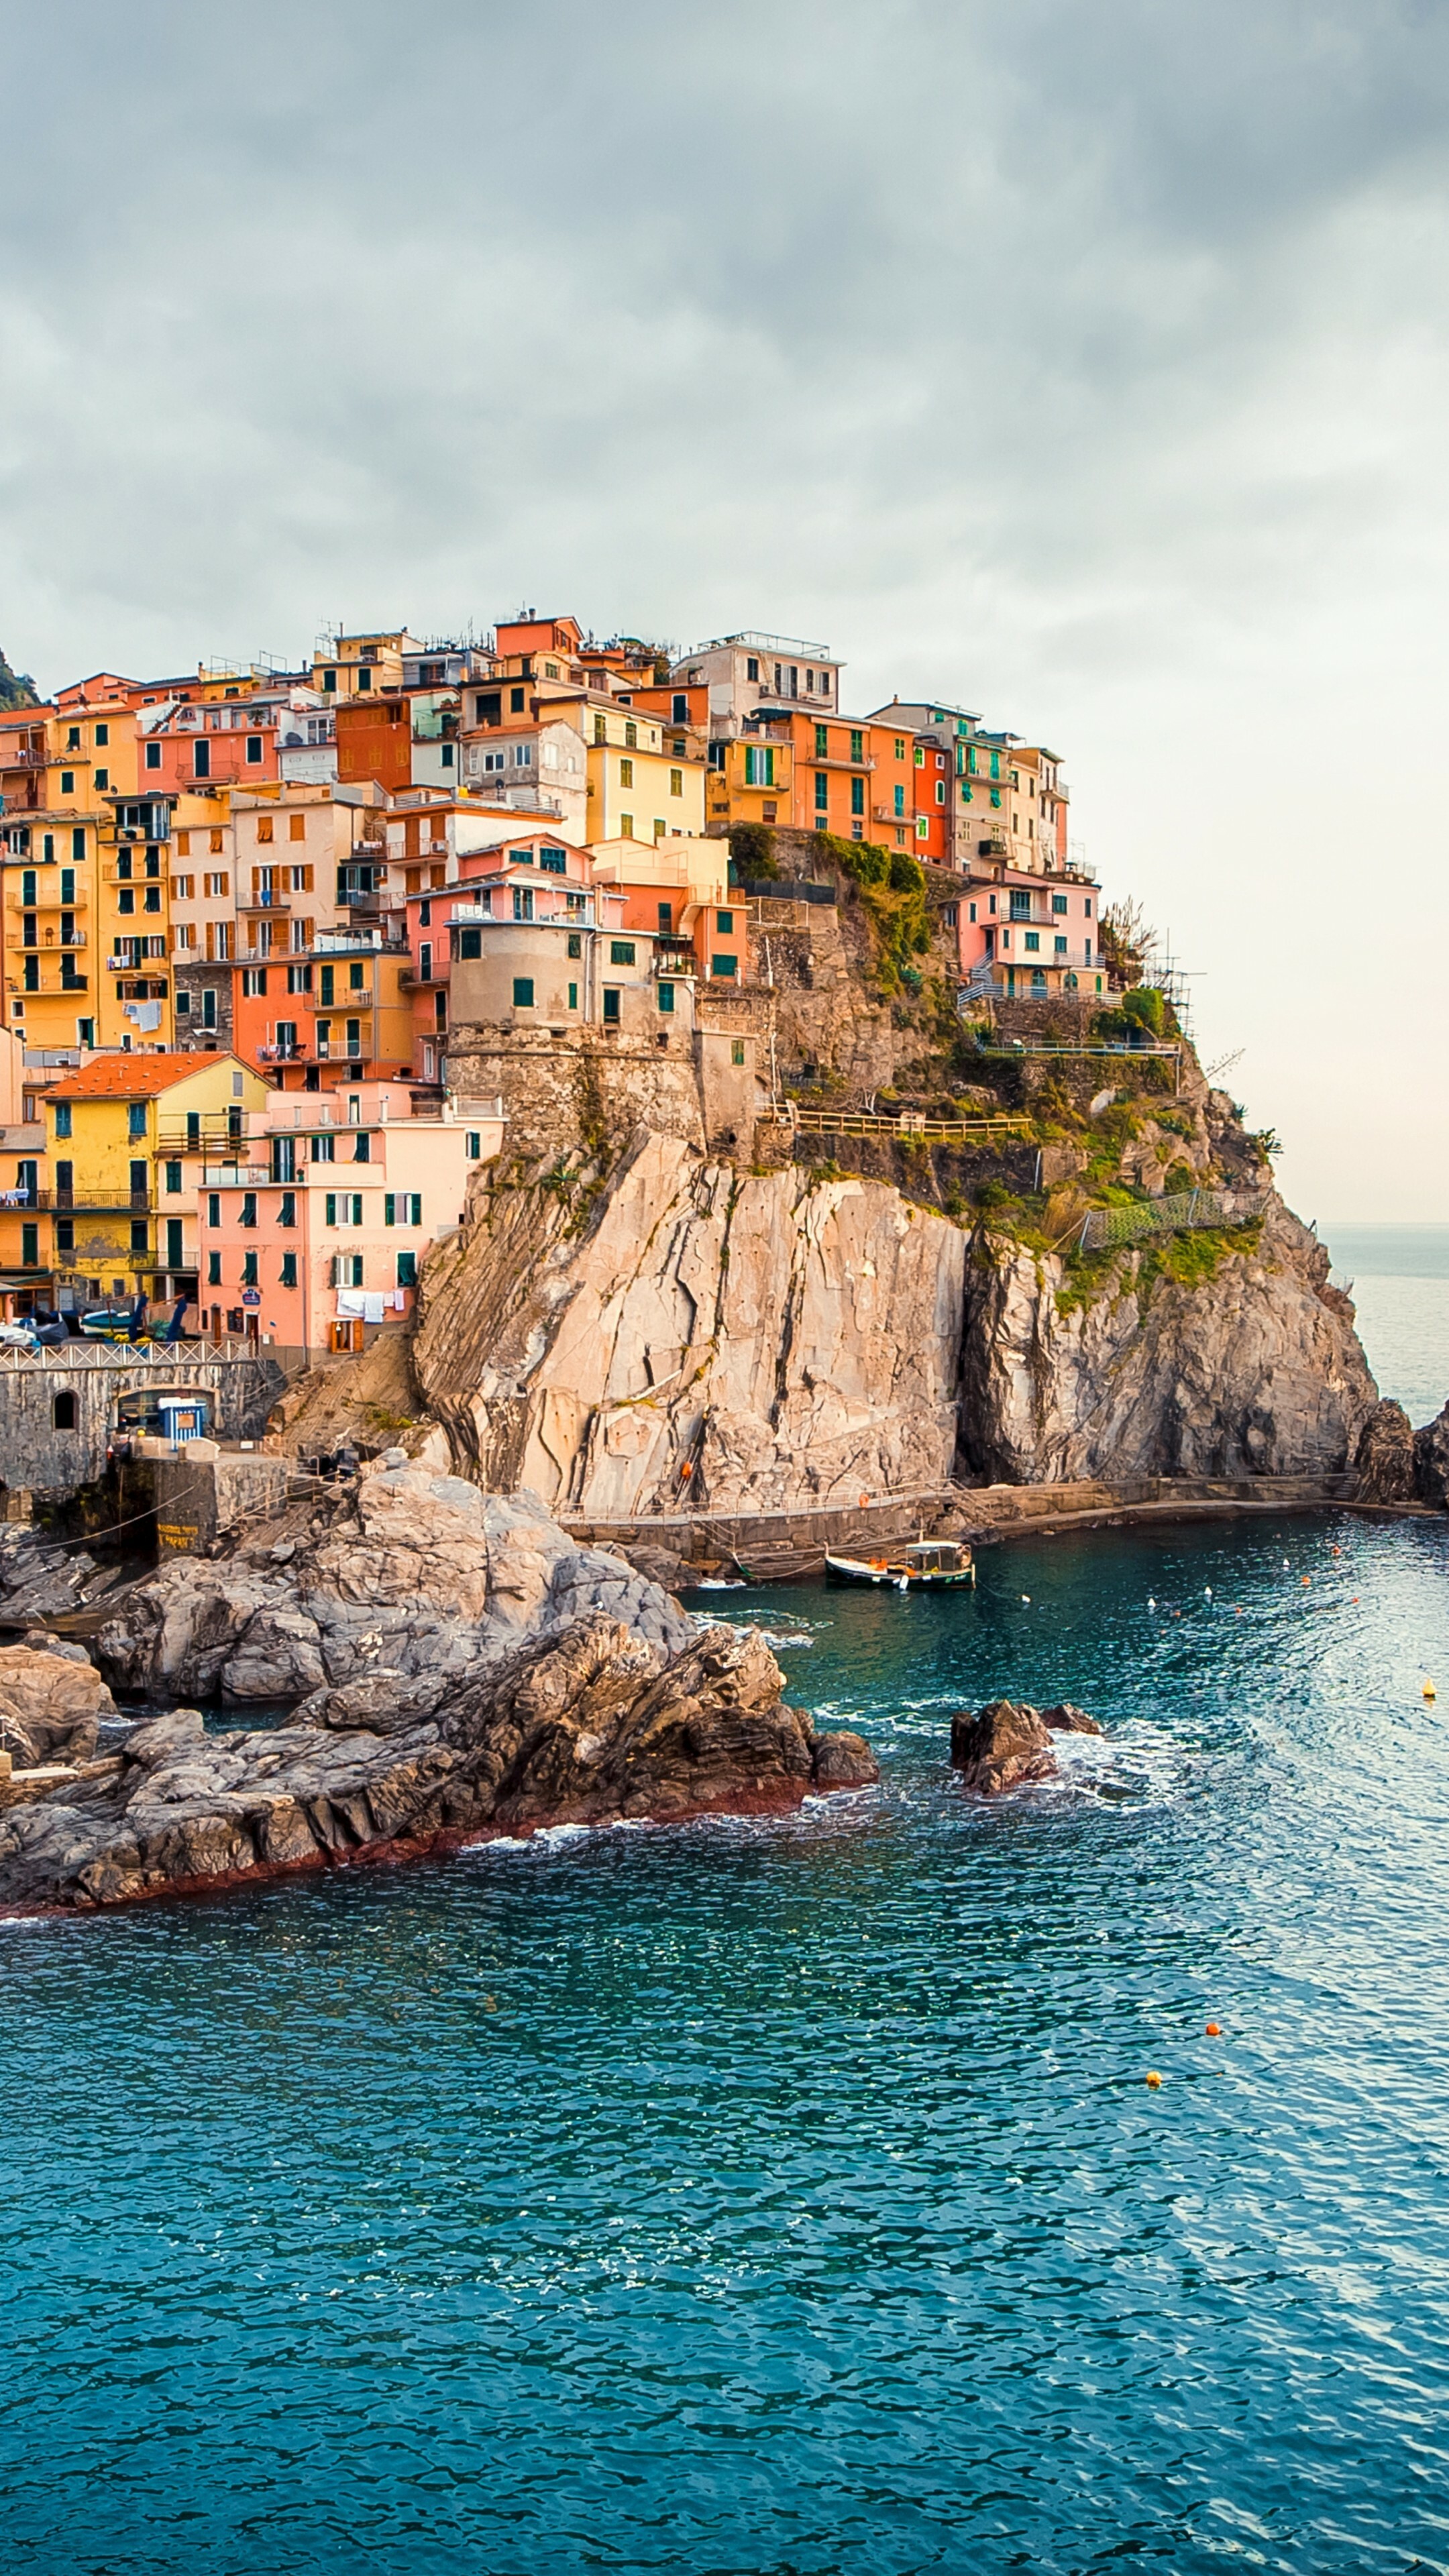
xmin=196 ymin=1082 xmax=502 ymax=1350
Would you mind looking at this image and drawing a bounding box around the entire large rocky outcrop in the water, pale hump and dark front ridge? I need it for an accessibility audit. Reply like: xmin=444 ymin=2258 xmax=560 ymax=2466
xmin=0 ymin=1466 xmax=877 ymax=1911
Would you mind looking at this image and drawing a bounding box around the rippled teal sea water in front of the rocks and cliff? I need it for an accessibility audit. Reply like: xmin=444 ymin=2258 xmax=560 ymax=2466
xmin=0 ymin=1520 xmax=1449 ymax=2576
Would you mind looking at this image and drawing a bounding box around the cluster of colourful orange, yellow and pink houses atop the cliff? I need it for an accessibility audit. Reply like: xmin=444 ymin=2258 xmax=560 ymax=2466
xmin=0 ymin=610 xmax=1106 ymax=1352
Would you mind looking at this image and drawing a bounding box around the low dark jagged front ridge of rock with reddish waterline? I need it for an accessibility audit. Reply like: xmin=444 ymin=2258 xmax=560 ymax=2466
xmin=0 ymin=1615 xmax=874 ymax=1911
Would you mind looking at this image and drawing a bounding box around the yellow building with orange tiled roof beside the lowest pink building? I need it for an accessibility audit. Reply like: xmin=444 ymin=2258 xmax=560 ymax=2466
xmin=36 ymin=1054 xmax=268 ymax=1298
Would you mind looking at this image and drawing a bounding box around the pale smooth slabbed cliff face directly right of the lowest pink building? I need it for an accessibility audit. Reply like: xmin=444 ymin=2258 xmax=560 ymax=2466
xmin=415 ymin=1131 xmax=967 ymax=1517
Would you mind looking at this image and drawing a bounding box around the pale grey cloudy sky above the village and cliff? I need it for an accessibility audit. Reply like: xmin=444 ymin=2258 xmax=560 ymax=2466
xmin=0 ymin=0 xmax=1449 ymax=1224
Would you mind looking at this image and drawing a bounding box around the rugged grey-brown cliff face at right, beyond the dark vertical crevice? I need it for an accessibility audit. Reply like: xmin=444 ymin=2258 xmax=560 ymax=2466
xmin=962 ymin=1198 xmax=1377 ymax=1484
